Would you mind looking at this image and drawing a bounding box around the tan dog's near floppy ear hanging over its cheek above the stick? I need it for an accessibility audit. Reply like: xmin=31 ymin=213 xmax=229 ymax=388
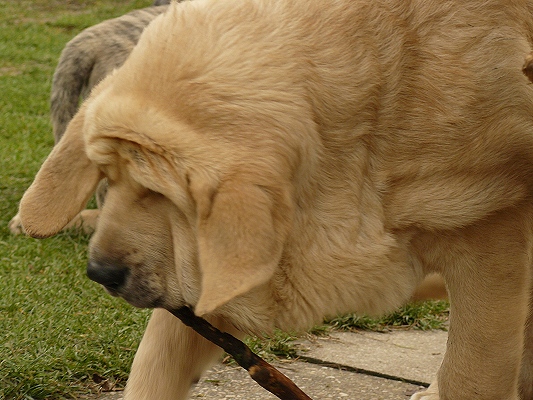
xmin=190 ymin=174 xmax=290 ymax=315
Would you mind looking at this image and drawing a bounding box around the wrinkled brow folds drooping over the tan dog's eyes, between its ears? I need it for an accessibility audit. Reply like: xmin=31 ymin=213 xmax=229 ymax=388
xmin=83 ymin=91 xmax=200 ymax=216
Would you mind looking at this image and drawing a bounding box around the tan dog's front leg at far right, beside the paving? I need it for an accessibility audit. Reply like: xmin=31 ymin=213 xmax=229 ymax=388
xmin=431 ymin=207 xmax=531 ymax=400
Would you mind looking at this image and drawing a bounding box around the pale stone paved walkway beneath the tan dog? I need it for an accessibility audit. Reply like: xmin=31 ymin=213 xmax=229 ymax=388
xmin=88 ymin=330 xmax=447 ymax=400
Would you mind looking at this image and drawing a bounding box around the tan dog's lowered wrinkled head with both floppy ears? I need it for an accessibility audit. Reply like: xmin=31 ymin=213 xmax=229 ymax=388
xmin=20 ymin=41 xmax=298 ymax=315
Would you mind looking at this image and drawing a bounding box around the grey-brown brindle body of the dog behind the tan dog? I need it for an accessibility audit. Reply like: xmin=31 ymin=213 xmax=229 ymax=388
xmin=50 ymin=6 xmax=167 ymax=143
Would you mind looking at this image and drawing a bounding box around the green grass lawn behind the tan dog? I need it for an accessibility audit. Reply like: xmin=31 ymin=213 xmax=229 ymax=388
xmin=0 ymin=0 xmax=446 ymax=399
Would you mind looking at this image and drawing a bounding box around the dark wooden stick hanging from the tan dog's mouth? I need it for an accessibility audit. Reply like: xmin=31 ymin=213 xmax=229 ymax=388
xmin=169 ymin=306 xmax=312 ymax=400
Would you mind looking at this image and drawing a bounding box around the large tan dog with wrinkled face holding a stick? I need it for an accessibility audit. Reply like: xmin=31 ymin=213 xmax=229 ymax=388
xmin=20 ymin=0 xmax=533 ymax=400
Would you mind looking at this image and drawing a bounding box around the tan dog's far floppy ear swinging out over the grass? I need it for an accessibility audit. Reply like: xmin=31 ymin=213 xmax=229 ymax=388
xmin=19 ymin=106 xmax=101 ymax=238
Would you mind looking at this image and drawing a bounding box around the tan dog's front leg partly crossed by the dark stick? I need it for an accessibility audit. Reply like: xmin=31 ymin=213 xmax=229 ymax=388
xmin=124 ymin=309 xmax=235 ymax=400
